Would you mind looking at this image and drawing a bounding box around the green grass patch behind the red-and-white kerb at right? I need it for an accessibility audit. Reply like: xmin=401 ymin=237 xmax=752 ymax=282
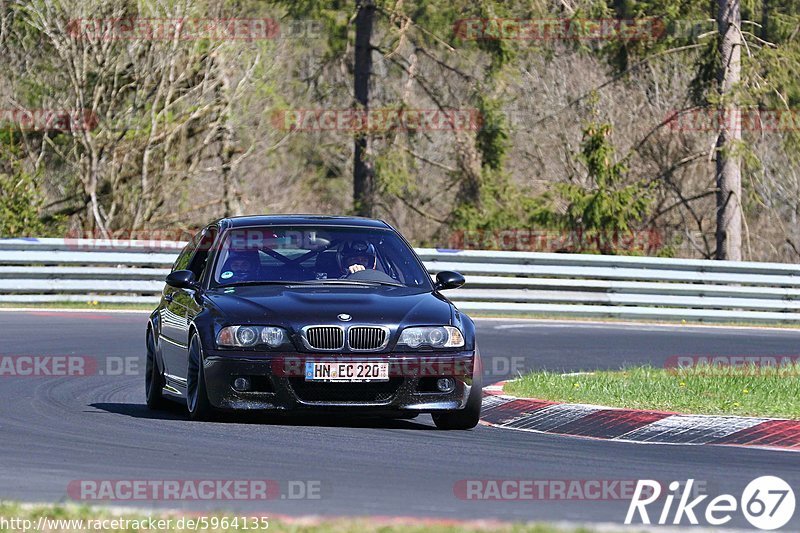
xmin=504 ymin=363 xmax=800 ymax=419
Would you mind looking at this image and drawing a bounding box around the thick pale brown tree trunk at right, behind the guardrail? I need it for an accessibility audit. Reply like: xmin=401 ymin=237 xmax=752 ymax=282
xmin=716 ymin=0 xmax=742 ymax=261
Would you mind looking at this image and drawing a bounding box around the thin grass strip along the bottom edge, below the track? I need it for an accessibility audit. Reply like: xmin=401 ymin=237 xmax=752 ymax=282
xmin=0 ymin=502 xmax=607 ymax=533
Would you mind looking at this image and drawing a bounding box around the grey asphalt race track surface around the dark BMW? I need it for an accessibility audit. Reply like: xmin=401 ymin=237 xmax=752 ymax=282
xmin=0 ymin=311 xmax=800 ymax=531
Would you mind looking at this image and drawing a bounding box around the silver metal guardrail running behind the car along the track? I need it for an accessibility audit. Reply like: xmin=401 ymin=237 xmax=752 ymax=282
xmin=0 ymin=238 xmax=800 ymax=322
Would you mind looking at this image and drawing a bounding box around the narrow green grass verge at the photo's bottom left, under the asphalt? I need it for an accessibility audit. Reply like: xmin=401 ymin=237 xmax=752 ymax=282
xmin=0 ymin=502 xmax=608 ymax=533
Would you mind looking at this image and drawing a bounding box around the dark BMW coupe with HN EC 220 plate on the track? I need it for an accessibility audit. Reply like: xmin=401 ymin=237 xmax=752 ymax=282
xmin=146 ymin=215 xmax=482 ymax=429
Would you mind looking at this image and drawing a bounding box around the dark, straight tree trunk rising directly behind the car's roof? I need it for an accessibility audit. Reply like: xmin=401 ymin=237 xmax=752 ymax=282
xmin=353 ymin=0 xmax=375 ymax=217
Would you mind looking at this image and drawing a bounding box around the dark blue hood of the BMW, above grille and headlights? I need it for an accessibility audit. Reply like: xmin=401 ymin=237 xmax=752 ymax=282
xmin=206 ymin=285 xmax=453 ymax=330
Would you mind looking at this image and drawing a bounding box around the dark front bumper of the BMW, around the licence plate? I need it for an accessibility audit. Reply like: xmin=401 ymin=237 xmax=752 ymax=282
xmin=204 ymin=351 xmax=481 ymax=414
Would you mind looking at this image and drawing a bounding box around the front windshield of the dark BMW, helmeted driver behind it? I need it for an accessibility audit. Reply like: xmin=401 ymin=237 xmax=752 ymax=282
xmin=212 ymin=226 xmax=430 ymax=288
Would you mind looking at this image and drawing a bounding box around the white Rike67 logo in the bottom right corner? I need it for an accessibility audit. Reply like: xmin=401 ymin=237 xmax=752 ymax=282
xmin=625 ymin=476 xmax=795 ymax=530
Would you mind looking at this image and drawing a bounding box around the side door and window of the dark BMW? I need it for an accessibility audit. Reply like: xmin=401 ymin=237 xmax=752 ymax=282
xmin=159 ymin=232 xmax=203 ymax=385
